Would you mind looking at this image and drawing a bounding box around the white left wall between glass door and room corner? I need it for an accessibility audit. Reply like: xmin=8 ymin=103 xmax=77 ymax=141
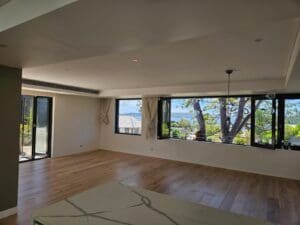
xmin=22 ymin=90 xmax=100 ymax=157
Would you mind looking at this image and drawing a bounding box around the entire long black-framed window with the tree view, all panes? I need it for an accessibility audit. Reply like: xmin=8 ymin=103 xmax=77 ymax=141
xmin=158 ymin=95 xmax=300 ymax=149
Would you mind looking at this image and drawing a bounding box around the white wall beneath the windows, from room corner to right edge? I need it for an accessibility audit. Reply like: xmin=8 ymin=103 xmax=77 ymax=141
xmin=100 ymin=100 xmax=300 ymax=179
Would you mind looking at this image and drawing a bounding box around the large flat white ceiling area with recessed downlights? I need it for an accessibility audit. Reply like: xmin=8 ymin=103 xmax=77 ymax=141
xmin=0 ymin=0 xmax=300 ymax=95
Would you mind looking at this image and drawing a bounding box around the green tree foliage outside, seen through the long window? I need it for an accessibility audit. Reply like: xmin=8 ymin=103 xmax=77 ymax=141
xmin=171 ymin=98 xmax=300 ymax=145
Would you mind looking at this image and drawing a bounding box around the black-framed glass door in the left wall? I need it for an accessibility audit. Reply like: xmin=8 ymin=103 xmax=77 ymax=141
xmin=19 ymin=96 xmax=52 ymax=162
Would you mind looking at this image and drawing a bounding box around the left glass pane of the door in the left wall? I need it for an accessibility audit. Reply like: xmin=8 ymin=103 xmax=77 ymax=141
xmin=19 ymin=96 xmax=34 ymax=161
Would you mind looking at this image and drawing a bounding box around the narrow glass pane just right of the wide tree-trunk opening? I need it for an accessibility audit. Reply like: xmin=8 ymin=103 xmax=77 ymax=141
xmin=255 ymin=99 xmax=273 ymax=145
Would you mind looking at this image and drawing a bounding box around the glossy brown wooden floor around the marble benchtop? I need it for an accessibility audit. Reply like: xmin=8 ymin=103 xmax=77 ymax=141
xmin=0 ymin=151 xmax=300 ymax=225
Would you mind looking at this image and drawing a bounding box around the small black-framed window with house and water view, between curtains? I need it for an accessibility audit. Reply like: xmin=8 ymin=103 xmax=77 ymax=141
xmin=115 ymin=99 xmax=142 ymax=135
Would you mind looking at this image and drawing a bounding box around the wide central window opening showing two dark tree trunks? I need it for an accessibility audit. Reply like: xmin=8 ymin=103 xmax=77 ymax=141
xmin=162 ymin=97 xmax=251 ymax=145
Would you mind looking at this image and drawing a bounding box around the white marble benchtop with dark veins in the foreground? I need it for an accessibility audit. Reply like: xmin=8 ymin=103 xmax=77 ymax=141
xmin=31 ymin=182 xmax=278 ymax=225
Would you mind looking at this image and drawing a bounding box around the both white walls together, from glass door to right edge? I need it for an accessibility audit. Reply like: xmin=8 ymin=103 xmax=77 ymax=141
xmin=23 ymin=91 xmax=300 ymax=180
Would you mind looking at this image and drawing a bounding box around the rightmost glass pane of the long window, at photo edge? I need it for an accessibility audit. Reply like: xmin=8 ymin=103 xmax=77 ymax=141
xmin=284 ymin=99 xmax=300 ymax=148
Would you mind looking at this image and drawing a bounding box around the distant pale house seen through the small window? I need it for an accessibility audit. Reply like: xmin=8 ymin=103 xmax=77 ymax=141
xmin=119 ymin=115 xmax=142 ymax=134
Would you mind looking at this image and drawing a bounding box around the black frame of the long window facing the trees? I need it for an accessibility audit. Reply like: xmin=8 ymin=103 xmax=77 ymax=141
xmin=157 ymin=93 xmax=300 ymax=150
